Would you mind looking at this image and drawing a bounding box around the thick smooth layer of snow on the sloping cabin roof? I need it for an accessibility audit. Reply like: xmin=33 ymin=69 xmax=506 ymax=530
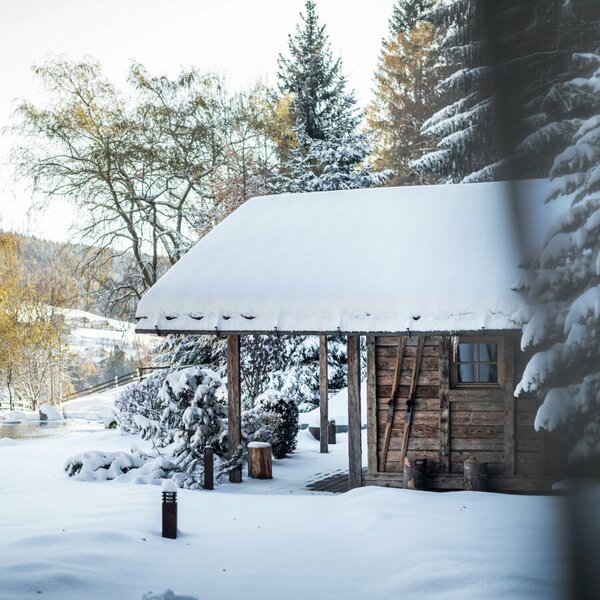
xmin=137 ymin=180 xmax=561 ymax=333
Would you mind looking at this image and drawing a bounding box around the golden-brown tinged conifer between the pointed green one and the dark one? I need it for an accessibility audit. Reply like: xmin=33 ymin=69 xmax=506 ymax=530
xmin=367 ymin=0 xmax=444 ymax=185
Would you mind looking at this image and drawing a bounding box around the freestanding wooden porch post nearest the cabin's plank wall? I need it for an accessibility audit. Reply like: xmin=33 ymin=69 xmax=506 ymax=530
xmin=347 ymin=335 xmax=362 ymax=489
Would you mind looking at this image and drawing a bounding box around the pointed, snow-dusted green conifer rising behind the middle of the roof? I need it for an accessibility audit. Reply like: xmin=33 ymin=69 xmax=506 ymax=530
xmin=276 ymin=0 xmax=386 ymax=192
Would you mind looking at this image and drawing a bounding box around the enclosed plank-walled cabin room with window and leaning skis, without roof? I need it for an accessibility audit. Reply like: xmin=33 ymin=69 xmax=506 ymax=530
xmin=365 ymin=331 xmax=556 ymax=492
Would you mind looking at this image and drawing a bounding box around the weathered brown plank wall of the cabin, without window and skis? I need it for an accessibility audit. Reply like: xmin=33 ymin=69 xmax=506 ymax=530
xmin=365 ymin=333 xmax=553 ymax=492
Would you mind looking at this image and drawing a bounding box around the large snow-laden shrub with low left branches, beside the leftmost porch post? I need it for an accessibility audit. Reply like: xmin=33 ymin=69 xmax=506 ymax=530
xmin=65 ymin=367 xmax=234 ymax=489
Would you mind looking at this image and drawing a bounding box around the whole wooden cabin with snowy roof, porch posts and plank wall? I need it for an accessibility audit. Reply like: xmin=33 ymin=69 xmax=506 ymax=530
xmin=136 ymin=181 xmax=563 ymax=492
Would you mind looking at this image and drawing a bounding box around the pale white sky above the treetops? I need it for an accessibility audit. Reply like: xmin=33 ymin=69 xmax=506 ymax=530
xmin=0 ymin=0 xmax=395 ymax=241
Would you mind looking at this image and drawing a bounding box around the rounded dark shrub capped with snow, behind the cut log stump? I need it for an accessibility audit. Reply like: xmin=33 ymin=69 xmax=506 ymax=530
xmin=252 ymin=390 xmax=299 ymax=458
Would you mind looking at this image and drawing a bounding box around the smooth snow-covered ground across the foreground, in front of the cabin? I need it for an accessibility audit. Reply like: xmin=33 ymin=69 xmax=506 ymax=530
xmin=0 ymin=430 xmax=565 ymax=600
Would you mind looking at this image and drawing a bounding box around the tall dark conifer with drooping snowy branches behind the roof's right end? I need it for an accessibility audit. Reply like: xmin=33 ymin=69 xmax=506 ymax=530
xmin=414 ymin=0 xmax=600 ymax=182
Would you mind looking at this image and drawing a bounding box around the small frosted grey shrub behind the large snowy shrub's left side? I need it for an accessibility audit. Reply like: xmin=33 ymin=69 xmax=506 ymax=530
xmin=115 ymin=370 xmax=166 ymax=434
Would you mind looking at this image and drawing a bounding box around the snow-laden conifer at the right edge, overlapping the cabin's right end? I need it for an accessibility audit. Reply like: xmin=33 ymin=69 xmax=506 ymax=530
xmin=517 ymin=53 xmax=600 ymax=463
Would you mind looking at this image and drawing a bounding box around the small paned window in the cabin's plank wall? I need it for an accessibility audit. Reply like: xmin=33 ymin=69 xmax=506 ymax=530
xmin=452 ymin=336 xmax=503 ymax=387
